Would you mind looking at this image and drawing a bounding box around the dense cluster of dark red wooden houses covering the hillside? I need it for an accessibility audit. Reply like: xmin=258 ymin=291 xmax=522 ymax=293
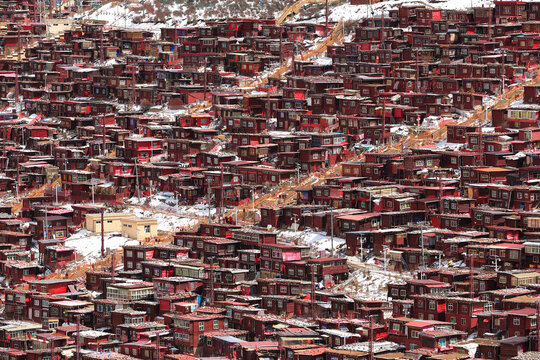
xmin=0 ymin=0 xmax=540 ymax=360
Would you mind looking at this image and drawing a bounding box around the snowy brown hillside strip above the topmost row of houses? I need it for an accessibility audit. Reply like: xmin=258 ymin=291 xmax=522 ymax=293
xmin=79 ymin=0 xmax=493 ymax=32
